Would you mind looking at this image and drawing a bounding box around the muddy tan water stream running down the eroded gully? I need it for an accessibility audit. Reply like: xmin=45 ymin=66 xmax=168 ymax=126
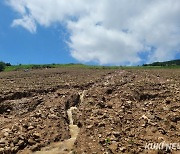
xmin=35 ymin=90 xmax=86 ymax=154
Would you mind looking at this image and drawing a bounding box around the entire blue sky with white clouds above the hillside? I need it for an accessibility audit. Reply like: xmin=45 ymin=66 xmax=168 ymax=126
xmin=0 ymin=0 xmax=180 ymax=65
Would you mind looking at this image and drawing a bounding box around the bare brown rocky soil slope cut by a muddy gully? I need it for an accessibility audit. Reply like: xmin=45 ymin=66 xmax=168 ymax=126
xmin=0 ymin=68 xmax=180 ymax=154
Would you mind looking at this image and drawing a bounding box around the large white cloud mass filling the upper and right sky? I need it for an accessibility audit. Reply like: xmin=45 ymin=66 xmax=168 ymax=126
xmin=6 ymin=0 xmax=180 ymax=64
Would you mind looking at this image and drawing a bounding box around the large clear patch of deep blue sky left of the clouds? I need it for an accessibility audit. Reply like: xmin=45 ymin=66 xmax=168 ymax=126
xmin=0 ymin=1 xmax=77 ymax=64
